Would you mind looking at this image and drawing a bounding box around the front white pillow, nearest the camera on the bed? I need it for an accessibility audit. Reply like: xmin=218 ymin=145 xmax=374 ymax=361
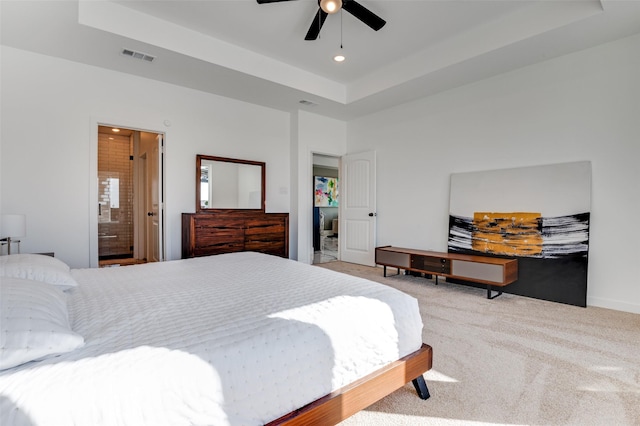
xmin=0 ymin=277 xmax=84 ymax=370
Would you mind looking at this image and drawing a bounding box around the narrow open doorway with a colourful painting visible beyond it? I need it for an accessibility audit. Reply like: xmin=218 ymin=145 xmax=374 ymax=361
xmin=313 ymin=154 xmax=340 ymax=264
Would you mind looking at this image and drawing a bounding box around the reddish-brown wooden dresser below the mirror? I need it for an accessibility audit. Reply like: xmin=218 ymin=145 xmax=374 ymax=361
xmin=182 ymin=210 xmax=289 ymax=259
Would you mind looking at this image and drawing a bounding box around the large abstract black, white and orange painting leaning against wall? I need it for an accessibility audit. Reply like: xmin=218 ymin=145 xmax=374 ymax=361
xmin=448 ymin=162 xmax=591 ymax=306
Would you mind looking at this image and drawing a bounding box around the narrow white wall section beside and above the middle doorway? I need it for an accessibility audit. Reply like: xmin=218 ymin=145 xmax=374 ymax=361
xmin=297 ymin=111 xmax=347 ymax=263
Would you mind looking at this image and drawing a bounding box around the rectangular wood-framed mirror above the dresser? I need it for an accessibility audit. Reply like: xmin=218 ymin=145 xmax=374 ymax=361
xmin=196 ymin=155 xmax=265 ymax=213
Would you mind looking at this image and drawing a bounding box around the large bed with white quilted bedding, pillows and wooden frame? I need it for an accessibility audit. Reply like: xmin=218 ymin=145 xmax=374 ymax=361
xmin=0 ymin=252 xmax=432 ymax=425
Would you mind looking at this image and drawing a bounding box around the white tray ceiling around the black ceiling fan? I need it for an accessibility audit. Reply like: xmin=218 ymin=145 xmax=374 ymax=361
xmin=0 ymin=0 xmax=640 ymax=120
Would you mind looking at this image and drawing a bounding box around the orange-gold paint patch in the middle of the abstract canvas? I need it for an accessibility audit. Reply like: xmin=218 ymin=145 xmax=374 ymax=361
xmin=471 ymin=212 xmax=542 ymax=256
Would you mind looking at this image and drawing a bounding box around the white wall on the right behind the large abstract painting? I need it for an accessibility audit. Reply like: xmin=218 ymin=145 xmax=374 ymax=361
xmin=348 ymin=35 xmax=640 ymax=313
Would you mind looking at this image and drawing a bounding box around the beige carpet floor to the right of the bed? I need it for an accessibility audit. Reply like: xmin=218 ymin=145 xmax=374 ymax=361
xmin=318 ymin=262 xmax=640 ymax=426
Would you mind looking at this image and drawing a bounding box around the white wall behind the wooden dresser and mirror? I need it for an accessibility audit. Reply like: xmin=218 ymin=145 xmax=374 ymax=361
xmin=0 ymin=46 xmax=291 ymax=267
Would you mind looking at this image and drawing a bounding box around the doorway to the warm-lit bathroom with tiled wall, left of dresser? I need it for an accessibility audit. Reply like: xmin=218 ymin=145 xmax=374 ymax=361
xmin=97 ymin=125 xmax=163 ymax=267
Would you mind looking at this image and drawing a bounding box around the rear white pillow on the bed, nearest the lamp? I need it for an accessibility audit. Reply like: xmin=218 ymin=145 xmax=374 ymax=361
xmin=0 ymin=254 xmax=78 ymax=290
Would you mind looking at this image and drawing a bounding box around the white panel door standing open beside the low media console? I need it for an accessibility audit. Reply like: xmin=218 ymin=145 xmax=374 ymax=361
xmin=338 ymin=151 xmax=376 ymax=266
